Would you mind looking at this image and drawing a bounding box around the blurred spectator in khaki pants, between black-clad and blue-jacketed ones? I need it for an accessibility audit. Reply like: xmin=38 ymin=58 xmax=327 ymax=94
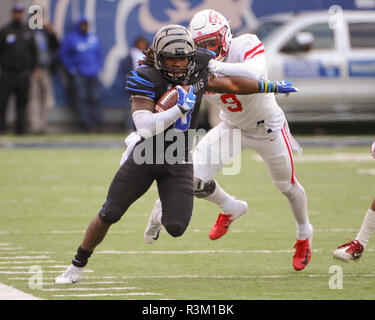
xmin=29 ymin=15 xmax=59 ymax=134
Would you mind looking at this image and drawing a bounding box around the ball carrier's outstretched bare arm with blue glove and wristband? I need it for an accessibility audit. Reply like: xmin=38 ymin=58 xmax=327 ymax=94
xmin=207 ymin=77 xmax=298 ymax=94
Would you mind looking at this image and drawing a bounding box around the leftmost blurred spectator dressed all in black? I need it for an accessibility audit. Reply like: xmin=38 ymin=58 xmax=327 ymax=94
xmin=0 ymin=4 xmax=38 ymax=134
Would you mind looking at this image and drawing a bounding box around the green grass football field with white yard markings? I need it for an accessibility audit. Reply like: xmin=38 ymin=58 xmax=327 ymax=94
xmin=0 ymin=134 xmax=375 ymax=300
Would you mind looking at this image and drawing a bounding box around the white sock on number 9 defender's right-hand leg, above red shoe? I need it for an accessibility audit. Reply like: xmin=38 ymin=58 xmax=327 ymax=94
xmin=283 ymin=181 xmax=311 ymax=240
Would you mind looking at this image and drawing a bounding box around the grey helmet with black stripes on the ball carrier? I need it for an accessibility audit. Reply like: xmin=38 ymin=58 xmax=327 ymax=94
xmin=152 ymin=24 xmax=195 ymax=82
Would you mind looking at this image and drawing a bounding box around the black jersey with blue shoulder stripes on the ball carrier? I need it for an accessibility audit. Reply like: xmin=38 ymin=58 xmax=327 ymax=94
xmin=126 ymin=49 xmax=214 ymax=161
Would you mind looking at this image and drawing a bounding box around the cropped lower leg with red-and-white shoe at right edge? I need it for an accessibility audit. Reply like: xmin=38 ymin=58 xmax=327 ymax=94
xmin=333 ymin=198 xmax=375 ymax=262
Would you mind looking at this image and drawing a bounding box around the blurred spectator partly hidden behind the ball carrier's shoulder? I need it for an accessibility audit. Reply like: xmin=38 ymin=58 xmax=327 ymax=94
xmin=119 ymin=36 xmax=149 ymax=131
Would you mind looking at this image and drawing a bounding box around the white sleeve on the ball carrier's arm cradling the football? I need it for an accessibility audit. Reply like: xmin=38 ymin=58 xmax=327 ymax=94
xmin=132 ymin=105 xmax=182 ymax=137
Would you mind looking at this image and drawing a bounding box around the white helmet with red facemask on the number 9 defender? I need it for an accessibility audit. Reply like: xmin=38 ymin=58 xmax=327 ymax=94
xmin=189 ymin=9 xmax=232 ymax=61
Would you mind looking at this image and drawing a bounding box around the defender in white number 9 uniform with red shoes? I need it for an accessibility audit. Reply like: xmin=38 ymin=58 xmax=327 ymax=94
xmin=189 ymin=10 xmax=313 ymax=271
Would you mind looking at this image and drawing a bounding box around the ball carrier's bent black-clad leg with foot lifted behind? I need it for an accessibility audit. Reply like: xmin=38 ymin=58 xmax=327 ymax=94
xmin=145 ymin=164 xmax=194 ymax=243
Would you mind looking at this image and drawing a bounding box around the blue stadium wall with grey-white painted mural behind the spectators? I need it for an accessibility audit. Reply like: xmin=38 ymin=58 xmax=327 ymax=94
xmin=0 ymin=0 xmax=375 ymax=129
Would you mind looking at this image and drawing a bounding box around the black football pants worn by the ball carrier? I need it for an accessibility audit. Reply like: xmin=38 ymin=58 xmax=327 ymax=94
xmin=99 ymin=155 xmax=194 ymax=237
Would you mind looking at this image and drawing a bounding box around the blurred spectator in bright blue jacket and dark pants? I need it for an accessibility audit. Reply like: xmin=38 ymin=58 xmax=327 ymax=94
xmin=60 ymin=16 xmax=103 ymax=133
